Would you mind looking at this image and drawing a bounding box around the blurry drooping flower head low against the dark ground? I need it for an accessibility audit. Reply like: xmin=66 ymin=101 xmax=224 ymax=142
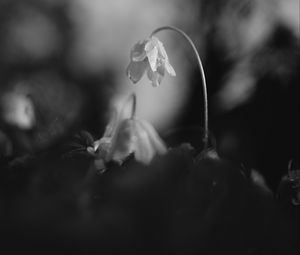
xmin=87 ymin=108 xmax=167 ymax=170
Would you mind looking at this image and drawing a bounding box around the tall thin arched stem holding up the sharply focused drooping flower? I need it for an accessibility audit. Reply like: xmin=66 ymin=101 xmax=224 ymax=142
xmin=150 ymin=26 xmax=208 ymax=150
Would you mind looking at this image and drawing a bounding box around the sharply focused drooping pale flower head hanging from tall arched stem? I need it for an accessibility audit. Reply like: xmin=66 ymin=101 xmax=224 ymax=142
xmin=126 ymin=36 xmax=176 ymax=87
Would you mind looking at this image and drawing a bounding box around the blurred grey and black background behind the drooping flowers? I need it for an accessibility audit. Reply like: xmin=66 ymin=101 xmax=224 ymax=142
xmin=0 ymin=0 xmax=300 ymax=188
